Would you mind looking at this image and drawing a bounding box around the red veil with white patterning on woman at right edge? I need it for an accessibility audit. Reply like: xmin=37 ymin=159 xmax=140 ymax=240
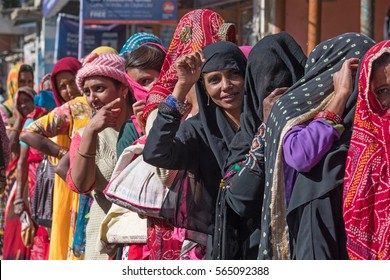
xmin=343 ymin=40 xmax=390 ymax=260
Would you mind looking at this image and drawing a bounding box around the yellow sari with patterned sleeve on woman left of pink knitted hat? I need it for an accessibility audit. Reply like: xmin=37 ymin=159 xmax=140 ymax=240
xmin=24 ymin=96 xmax=91 ymax=260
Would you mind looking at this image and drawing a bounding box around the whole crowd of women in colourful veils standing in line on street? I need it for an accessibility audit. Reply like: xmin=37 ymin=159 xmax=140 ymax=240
xmin=0 ymin=9 xmax=390 ymax=260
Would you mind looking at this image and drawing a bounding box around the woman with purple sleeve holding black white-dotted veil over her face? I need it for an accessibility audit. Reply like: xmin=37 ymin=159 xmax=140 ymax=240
xmin=258 ymin=33 xmax=373 ymax=259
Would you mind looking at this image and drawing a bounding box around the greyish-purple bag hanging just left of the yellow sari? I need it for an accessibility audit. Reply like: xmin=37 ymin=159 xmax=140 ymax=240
xmin=31 ymin=157 xmax=54 ymax=228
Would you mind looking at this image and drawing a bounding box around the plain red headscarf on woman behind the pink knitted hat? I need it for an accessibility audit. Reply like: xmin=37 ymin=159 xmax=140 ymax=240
xmin=50 ymin=57 xmax=81 ymax=107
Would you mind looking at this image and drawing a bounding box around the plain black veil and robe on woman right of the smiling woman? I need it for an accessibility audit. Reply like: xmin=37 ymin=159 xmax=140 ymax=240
xmin=213 ymin=32 xmax=306 ymax=259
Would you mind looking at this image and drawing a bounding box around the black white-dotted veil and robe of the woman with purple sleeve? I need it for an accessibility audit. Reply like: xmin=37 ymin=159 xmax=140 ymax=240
xmin=258 ymin=33 xmax=374 ymax=259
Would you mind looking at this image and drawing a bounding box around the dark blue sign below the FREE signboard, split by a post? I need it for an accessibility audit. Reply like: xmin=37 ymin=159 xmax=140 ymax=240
xmin=55 ymin=15 xmax=127 ymax=61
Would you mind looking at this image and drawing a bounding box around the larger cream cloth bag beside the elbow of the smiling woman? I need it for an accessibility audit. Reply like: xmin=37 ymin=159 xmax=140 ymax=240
xmin=103 ymin=143 xmax=168 ymax=217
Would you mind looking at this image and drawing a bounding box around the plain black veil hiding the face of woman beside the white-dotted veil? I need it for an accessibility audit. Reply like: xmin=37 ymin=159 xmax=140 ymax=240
xmin=224 ymin=32 xmax=306 ymax=171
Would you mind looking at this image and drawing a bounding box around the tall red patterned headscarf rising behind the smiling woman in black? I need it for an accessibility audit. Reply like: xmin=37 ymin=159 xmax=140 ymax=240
xmin=142 ymin=9 xmax=236 ymax=122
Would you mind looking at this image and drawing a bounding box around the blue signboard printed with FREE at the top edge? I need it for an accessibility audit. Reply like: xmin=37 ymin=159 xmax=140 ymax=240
xmin=81 ymin=0 xmax=178 ymax=24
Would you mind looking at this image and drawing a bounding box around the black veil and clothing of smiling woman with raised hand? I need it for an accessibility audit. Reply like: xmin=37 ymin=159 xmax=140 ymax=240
xmin=143 ymin=42 xmax=246 ymax=258
